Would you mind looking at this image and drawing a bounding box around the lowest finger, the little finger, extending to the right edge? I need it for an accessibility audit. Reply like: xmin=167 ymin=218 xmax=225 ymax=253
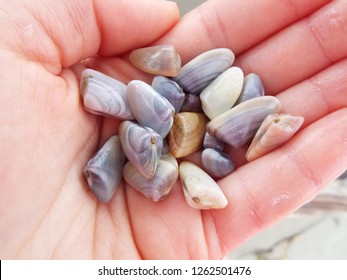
xmin=212 ymin=109 xmax=347 ymax=253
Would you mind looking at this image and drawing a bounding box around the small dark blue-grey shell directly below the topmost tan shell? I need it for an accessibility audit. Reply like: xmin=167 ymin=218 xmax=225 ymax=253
xmin=152 ymin=76 xmax=185 ymax=113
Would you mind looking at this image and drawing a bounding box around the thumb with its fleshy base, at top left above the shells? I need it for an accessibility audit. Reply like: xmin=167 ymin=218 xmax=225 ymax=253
xmin=0 ymin=0 xmax=178 ymax=74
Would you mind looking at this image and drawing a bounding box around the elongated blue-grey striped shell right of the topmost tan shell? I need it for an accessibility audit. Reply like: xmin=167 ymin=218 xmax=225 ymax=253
xmin=174 ymin=48 xmax=235 ymax=95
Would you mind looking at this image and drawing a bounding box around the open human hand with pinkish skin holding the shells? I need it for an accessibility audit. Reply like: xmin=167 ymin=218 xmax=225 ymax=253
xmin=0 ymin=0 xmax=347 ymax=259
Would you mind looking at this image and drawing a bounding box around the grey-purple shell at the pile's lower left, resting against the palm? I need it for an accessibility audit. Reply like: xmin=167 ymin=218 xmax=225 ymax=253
xmin=83 ymin=135 xmax=125 ymax=202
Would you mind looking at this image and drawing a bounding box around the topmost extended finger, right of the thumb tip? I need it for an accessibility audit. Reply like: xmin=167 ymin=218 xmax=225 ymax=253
xmin=157 ymin=0 xmax=330 ymax=61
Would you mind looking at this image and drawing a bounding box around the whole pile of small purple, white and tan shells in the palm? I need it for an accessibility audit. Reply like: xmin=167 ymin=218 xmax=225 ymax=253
xmin=81 ymin=45 xmax=303 ymax=209
